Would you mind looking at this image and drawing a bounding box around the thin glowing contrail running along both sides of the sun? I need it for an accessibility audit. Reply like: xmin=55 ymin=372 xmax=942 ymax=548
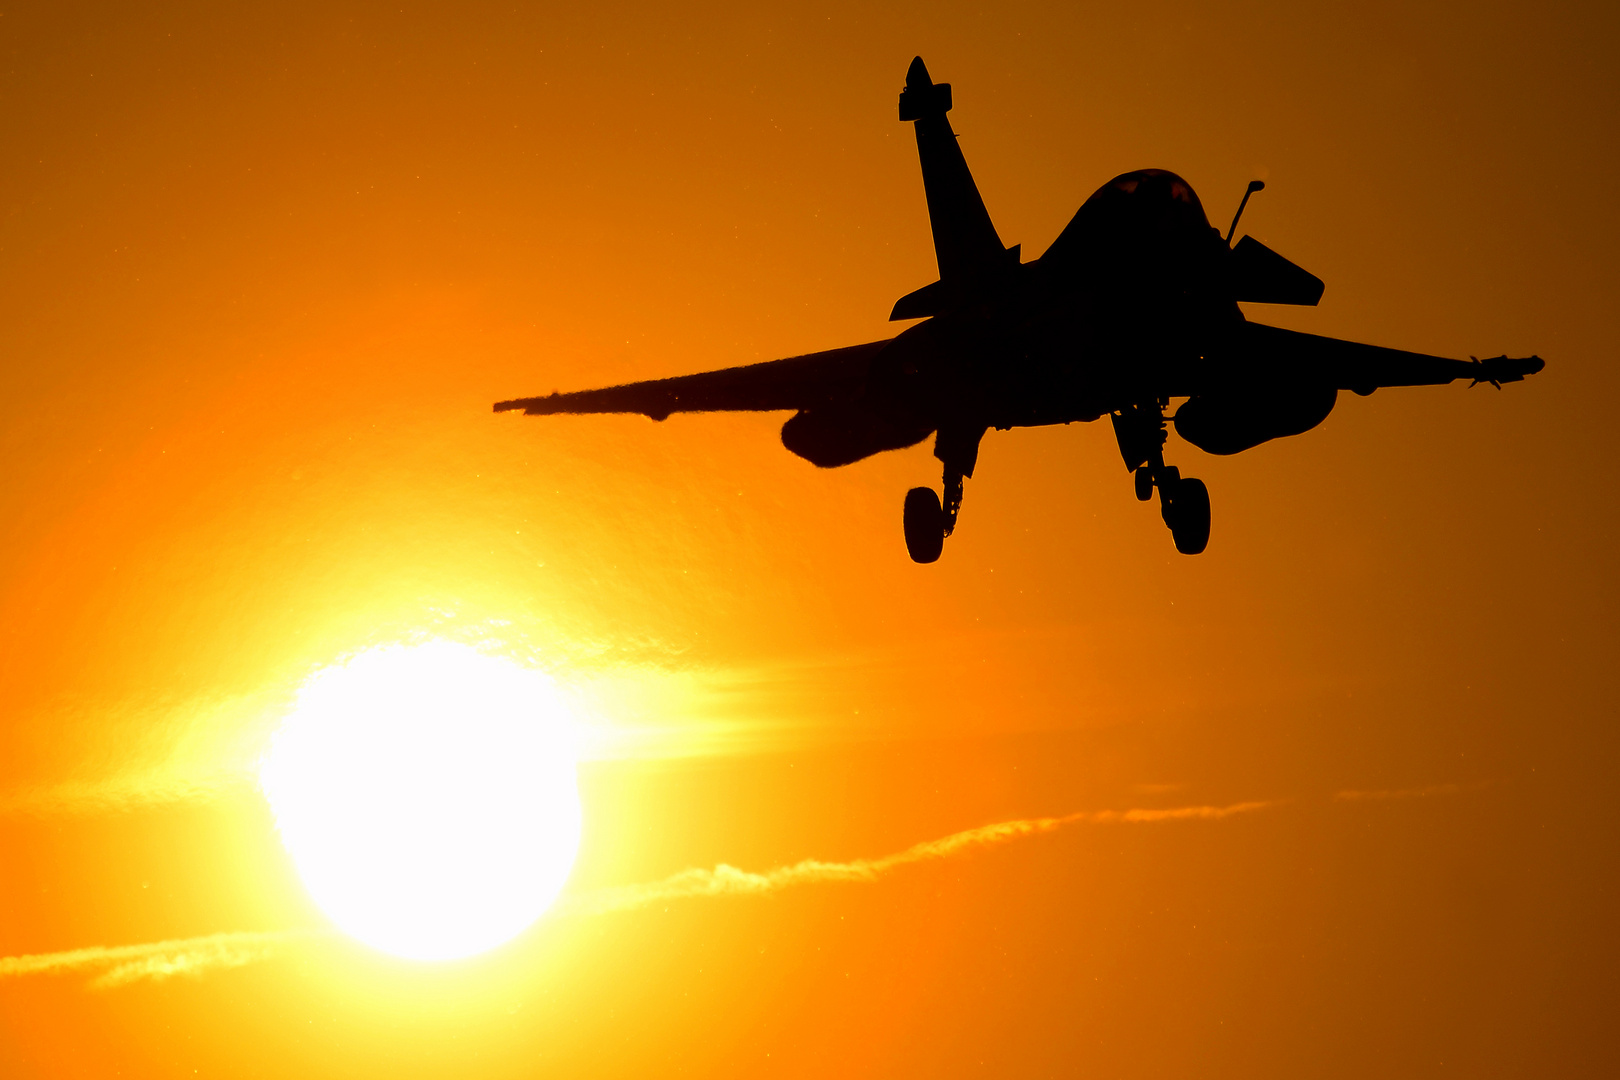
xmin=0 ymin=801 xmax=1275 ymax=989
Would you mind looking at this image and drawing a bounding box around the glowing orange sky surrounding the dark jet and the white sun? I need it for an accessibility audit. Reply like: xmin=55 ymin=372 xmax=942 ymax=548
xmin=0 ymin=3 xmax=1620 ymax=1078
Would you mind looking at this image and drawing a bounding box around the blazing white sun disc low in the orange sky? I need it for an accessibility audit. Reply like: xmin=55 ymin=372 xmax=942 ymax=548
xmin=259 ymin=641 xmax=580 ymax=960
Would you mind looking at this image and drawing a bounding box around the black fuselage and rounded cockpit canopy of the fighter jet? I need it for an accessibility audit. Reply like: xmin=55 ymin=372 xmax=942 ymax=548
xmin=873 ymin=170 xmax=1244 ymax=427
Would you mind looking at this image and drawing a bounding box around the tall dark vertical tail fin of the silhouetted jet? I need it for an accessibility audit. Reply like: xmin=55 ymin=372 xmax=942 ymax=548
xmin=901 ymin=57 xmax=1006 ymax=285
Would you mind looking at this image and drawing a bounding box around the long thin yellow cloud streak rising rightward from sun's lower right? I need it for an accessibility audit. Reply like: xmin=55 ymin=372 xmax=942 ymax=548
xmin=552 ymin=801 xmax=1273 ymax=915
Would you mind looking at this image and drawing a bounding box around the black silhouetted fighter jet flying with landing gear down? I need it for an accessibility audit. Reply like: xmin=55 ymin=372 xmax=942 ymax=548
xmin=494 ymin=57 xmax=1544 ymax=563
